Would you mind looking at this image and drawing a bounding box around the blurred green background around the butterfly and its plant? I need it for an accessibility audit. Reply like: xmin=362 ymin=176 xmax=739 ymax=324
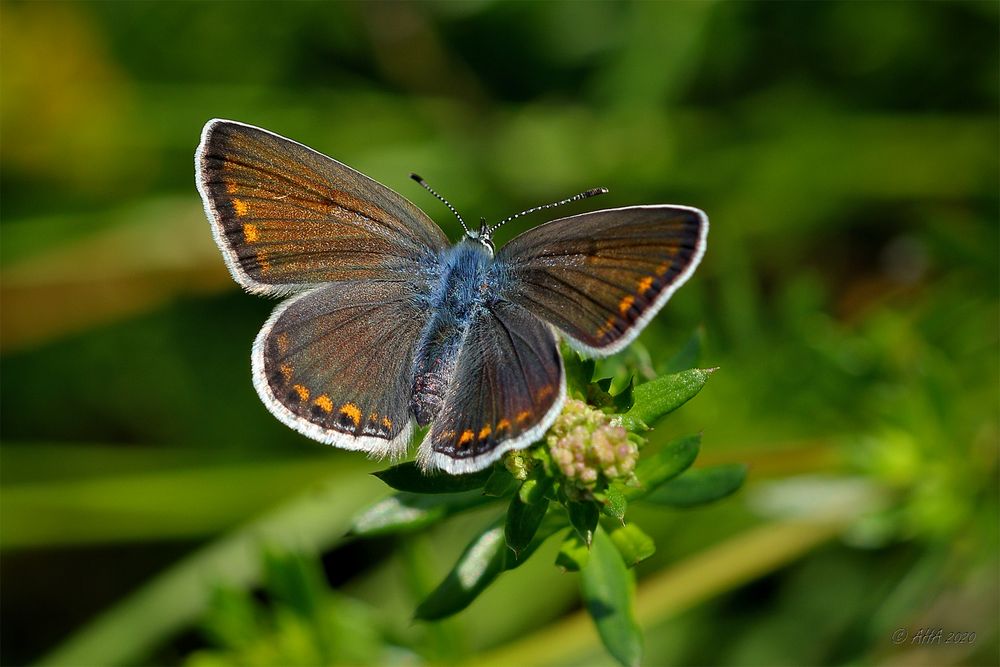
xmin=0 ymin=1 xmax=1000 ymax=665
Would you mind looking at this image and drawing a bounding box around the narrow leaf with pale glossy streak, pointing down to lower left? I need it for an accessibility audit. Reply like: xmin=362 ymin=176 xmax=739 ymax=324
xmin=414 ymin=519 xmax=509 ymax=621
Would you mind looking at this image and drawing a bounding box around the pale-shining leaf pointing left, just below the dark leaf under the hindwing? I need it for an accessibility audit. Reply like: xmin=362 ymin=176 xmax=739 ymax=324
xmin=350 ymin=491 xmax=493 ymax=537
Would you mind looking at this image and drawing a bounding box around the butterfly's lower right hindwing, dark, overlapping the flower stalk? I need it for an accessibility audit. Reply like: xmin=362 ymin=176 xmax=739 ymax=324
xmin=418 ymin=298 xmax=566 ymax=474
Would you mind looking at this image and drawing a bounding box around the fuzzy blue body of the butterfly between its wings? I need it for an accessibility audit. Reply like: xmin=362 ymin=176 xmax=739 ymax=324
xmin=410 ymin=238 xmax=498 ymax=426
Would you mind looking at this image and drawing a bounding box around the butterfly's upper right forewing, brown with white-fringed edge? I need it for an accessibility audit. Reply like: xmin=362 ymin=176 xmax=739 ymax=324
xmin=496 ymin=206 xmax=708 ymax=356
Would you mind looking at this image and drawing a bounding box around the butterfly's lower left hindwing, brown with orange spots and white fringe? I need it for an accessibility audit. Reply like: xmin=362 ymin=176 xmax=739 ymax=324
xmin=252 ymin=282 xmax=426 ymax=456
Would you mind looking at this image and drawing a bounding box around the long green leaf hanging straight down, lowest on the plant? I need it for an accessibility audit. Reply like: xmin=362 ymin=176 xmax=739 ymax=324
xmin=581 ymin=530 xmax=642 ymax=667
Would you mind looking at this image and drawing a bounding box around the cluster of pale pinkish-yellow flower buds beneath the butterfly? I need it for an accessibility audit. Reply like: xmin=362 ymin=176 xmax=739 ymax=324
xmin=546 ymin=399 xmax=639 ymax=489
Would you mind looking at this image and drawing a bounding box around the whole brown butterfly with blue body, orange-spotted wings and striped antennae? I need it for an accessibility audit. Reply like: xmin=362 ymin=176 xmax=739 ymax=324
xmin=195 ymin=119 xmax=708 ymax=474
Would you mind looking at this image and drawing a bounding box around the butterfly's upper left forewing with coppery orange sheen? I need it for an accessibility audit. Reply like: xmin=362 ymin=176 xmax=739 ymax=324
xmin=195 ymin=120 xmax=448 ymax=294
